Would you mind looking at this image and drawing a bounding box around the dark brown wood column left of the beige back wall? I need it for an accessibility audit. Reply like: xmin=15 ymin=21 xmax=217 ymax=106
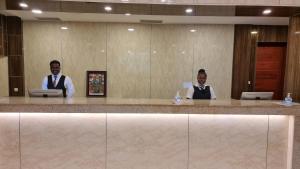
xmin=6 ymin=16 xmax=25 ymax=96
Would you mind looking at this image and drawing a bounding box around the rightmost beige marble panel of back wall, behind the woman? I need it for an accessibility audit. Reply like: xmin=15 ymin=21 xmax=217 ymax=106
xmin=193 ymin=25 xmax=234 ymax=99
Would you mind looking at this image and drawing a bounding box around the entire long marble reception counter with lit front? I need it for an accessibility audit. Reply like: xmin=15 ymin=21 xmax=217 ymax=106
xmin=0 ymin=97 xmax=300 ymax=169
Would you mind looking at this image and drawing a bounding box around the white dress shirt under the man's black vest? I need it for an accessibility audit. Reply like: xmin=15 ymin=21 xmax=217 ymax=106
xmin=42 ymin=73 xmax=75 ymax=97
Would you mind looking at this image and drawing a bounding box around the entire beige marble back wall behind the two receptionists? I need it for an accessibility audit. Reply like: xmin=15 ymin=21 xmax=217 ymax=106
xmin=24 ymin=21 xmax=234 ymax=99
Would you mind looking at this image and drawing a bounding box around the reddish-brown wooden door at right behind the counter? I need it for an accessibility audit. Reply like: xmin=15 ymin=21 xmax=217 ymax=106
xmin=254 ymin=43 xmax=286 ymax=100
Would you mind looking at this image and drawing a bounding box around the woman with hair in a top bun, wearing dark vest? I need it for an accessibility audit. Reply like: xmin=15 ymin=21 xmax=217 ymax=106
xmin=186 ymin=69 xmax=216 ymax=99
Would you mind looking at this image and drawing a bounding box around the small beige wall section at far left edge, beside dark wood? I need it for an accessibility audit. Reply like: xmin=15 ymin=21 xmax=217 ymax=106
xmin=0 ymin=56 xmax=9 ymax=96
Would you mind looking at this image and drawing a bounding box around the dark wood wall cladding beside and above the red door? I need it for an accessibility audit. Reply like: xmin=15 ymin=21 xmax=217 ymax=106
xmin=231 ymin=25 xmax=288 ymax=99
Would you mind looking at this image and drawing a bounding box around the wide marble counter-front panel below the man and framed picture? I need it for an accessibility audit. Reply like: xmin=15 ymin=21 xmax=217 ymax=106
xmin=20 ymin=113 xmax=106 ymax=169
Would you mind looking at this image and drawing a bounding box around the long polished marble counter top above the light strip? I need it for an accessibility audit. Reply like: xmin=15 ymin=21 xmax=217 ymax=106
xmin=0 ymin=97 xmax=300 ymax=116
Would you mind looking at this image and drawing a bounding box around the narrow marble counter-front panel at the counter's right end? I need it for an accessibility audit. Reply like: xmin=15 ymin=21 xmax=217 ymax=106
xmin=267 ymin=116 xmax=290 ymax=169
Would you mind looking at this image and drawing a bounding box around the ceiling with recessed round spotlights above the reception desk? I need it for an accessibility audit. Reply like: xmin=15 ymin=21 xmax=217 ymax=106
xmin=0 ymin=0 xmax=300 ymax=25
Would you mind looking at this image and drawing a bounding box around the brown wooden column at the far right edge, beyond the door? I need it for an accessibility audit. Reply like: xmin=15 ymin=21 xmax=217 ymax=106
xmin=284 ymin=15 xmax=300 ymax=103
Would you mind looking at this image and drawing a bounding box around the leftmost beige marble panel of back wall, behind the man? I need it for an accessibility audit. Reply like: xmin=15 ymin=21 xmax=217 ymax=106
xmin=23 ymin=22 xmax=63 ymax=94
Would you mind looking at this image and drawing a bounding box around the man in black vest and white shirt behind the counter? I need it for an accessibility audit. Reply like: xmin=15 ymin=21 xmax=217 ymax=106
xmin=42 ymin=60 xmax=75 ymax=97
